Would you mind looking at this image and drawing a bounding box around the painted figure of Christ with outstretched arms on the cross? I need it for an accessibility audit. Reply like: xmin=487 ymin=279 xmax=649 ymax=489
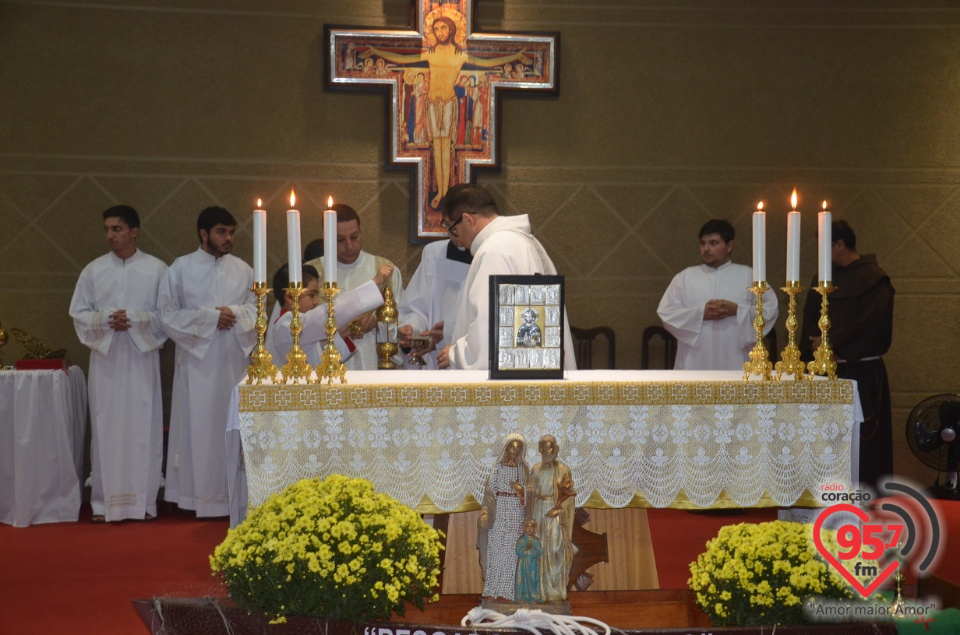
xmin=358 ymin=15 xmax=533 ymax=208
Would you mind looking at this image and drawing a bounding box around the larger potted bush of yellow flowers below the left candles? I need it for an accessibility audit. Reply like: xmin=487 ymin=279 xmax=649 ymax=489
xmin=210 ymin=474 xmax=443 ymax=622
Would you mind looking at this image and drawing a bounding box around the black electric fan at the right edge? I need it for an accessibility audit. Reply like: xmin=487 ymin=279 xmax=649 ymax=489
xmin=907 ymin=394 xmax=960 ymax=498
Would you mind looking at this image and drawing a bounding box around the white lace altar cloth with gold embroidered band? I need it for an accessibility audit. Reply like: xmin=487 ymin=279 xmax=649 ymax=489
xmin=238 ymin=371 xmax=862 ymax=512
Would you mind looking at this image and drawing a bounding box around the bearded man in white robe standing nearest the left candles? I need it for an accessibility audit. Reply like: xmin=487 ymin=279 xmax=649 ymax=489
xmin=157 ymin=207 xmax=257 ymax=517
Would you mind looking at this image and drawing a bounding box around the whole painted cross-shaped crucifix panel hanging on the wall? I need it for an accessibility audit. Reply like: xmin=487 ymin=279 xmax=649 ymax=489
xmin=324 ymin=0 xmax=559 ymax=242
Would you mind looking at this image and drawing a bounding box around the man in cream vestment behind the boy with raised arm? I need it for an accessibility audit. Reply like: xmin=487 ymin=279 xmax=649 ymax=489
xmin=306 ymin=203 xmax=403 ymax=370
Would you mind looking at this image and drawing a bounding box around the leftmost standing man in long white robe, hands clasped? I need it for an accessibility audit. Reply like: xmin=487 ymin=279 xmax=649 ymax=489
xmin=70 ymin=205 xmax=167 ymax=522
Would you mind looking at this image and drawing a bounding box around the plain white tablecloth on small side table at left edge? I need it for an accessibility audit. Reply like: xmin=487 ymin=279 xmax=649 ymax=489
xmin=0 ymin=366 xmax=87 ymax=527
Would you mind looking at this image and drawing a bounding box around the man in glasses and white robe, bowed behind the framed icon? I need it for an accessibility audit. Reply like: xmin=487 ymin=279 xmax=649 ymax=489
xmin=437 ymin=183 xmax=577 ymax=370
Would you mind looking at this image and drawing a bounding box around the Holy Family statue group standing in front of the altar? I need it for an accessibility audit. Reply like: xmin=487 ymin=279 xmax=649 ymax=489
xmin=477 ymin=433 xmax=577 ymax=612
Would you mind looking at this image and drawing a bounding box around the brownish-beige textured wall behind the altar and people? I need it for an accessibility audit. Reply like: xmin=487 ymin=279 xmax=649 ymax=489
xmin=0 ymin=0 xmax=960 ymax=481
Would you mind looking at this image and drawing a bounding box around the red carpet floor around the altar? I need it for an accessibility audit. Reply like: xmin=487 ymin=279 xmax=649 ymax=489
xmin=0 ymin=502 xmax=960 ymax=635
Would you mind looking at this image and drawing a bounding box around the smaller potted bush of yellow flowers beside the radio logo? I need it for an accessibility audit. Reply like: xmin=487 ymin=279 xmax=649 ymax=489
xmin=689 ymin=521 xmax=853 ymax=626
